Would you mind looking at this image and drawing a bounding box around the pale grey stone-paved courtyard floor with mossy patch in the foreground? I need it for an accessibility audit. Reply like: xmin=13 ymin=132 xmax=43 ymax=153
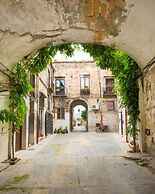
xmin=0 ymin=132 xmax=155 ymax=194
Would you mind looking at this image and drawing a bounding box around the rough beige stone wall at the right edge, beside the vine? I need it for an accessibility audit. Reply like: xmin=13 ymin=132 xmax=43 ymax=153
xmin=139 ymin=64 xmax=155 ymax=156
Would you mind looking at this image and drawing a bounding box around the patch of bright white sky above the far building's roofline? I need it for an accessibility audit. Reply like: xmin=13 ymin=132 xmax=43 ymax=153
xmin=54 ymin=48 xmax=93 ymax=61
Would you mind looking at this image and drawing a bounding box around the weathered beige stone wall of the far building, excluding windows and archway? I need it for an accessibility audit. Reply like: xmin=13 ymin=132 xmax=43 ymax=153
xmin=54 ymin=61 xmax=118 ymax=131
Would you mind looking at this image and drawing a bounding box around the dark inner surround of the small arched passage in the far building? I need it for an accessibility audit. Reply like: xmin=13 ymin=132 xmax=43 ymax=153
xmin=70 ymin=99 xmax=88 ymax=131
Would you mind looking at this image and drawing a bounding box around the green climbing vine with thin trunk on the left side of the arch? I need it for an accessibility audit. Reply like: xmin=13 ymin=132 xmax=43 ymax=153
xmin=0 ymin=44 xmax=76 ymax=160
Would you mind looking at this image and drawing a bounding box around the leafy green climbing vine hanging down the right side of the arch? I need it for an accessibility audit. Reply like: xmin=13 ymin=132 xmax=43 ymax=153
xmin=83 ymin=44 xmax=142 ymax=151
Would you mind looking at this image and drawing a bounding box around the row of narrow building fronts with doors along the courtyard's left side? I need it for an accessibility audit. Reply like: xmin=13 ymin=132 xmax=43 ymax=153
xmin=16 ymin=65 xmax=54 ymax=151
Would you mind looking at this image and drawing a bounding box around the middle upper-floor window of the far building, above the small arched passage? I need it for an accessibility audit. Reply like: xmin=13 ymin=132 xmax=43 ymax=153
xmin=80 ymin=76 xmax=90 ymax=95
